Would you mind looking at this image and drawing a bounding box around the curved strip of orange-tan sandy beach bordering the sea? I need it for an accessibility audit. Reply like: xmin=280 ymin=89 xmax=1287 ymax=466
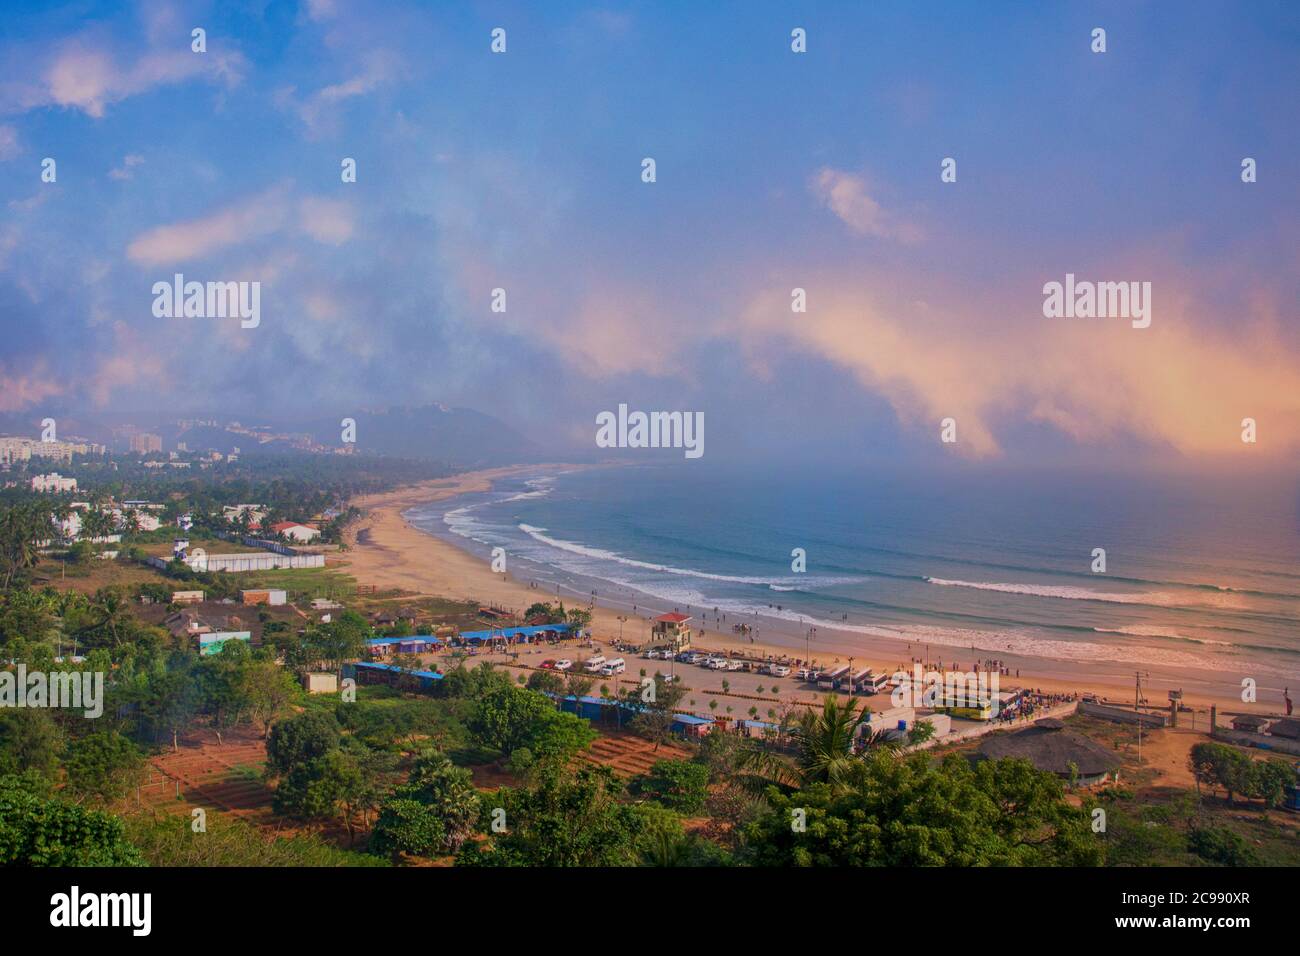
xmin=338 ymin=466 xmax=1279 ymax=713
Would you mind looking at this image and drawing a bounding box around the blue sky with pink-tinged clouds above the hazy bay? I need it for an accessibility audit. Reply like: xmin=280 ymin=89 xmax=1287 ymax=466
xmin=0 ymin=0 xmax=1300 ymax=467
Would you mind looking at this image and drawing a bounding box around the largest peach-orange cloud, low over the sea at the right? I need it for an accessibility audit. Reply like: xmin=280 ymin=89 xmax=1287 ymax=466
xmin=738 ymin=285 xmax=1300 ymax=458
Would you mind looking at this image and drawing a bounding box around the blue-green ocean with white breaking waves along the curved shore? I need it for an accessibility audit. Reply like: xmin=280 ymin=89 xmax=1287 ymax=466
xmin=406 ymin=462 xmax=1300 ymax=700
